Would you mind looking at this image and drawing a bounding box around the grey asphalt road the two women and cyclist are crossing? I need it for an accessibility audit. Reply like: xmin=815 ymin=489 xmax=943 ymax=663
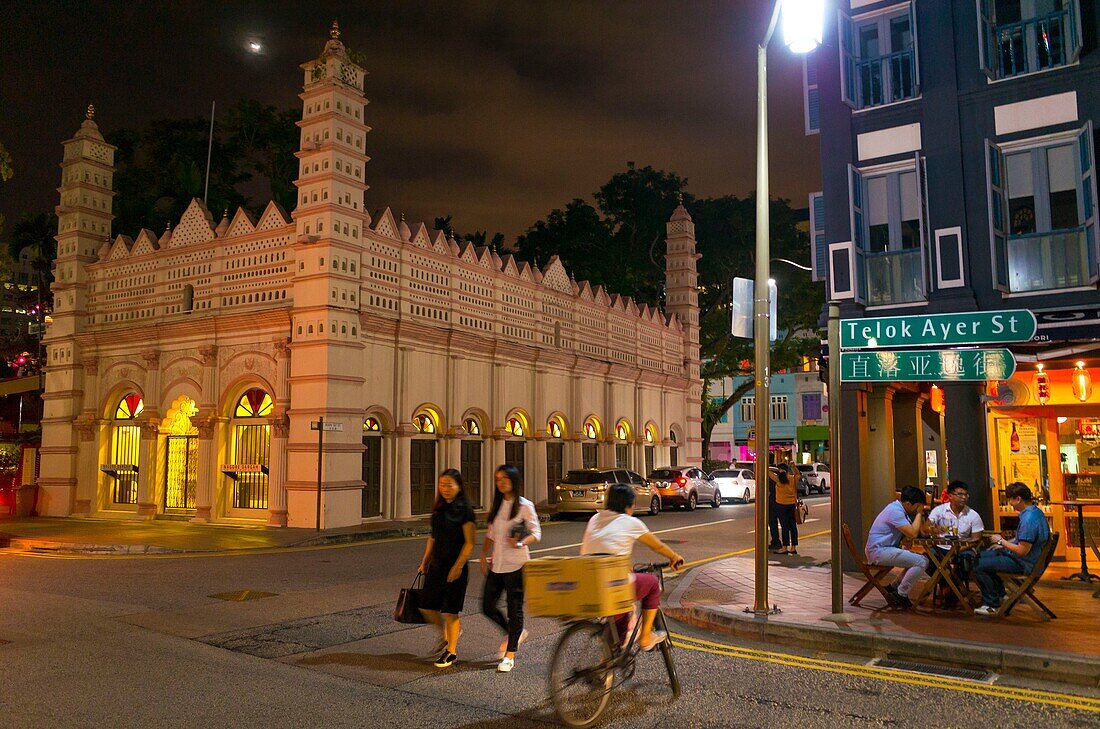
xmin=0 ymin=506 xmax=1100 ymax=729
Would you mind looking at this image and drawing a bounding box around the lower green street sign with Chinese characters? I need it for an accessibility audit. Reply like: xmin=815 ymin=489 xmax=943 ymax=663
xmin=840 ymin=350 xmax=1016 ymax=383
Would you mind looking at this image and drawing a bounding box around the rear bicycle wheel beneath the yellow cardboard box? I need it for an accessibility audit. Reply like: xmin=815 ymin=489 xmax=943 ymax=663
xmin=549 ymin=621 xmax=615 ymax=727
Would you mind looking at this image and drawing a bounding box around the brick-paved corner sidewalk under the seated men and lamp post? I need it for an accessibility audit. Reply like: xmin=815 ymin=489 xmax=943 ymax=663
xmin=667 ymin=538 xmax=1100 ymax=687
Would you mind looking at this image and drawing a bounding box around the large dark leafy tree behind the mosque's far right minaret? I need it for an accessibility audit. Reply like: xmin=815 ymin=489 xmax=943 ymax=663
xmin=516 ymin=164 xmax=823 ymax=454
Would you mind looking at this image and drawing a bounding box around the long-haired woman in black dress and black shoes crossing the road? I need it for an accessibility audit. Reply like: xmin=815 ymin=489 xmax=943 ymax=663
xmin=418 ymin=468 xmax=474 ymax=669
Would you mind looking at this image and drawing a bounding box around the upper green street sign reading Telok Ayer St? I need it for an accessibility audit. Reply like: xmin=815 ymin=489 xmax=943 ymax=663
xmin=840 ymin=309 xmax=1036 ymax=350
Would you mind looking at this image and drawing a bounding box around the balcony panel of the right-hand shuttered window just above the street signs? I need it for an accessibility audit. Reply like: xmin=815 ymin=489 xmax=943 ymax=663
xmin=1008 ymin=225 xmax=1092 ymax=294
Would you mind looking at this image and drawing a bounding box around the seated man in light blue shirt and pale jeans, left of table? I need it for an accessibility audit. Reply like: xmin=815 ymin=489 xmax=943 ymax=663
xmin=866 ymin=486 xmax=928 ymax=608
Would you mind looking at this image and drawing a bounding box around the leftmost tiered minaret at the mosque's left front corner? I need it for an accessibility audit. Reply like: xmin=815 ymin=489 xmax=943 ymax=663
xmin=39 ymin=104 xmax=116 ymax=516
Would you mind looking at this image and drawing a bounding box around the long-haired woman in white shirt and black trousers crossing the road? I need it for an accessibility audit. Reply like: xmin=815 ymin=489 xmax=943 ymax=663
xmin=481 ymin=465 xmax=542 ymax=673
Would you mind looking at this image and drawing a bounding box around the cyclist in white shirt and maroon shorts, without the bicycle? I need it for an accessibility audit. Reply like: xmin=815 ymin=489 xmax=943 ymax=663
xmin=581 ymin=484 xmax=684 ymax=651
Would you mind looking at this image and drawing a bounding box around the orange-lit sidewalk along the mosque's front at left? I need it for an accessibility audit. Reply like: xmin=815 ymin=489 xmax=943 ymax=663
xmin=0 ymin=512 xmax=549 ymax=555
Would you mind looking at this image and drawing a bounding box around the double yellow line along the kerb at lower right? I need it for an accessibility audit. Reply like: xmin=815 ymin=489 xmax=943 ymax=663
xmin=672 ymin=634 xmax=1100 ymax=713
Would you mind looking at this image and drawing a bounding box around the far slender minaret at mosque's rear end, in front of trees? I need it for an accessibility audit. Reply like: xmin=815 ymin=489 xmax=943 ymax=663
xmin=664 ymin=196 xmax=703 ymax=463
